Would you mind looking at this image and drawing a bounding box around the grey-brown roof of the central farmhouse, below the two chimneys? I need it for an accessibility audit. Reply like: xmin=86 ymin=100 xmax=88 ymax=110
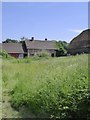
xmin=25 ymin=40 xmax=57 ymax=49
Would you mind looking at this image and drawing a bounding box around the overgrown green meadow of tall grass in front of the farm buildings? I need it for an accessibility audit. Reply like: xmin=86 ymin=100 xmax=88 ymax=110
xmin=2 ymin=54 xmax=89 ymax=119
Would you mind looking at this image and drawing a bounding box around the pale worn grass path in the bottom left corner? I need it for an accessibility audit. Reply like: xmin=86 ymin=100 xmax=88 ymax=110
xmin=2 ymin=89 xmax=35 ymax=118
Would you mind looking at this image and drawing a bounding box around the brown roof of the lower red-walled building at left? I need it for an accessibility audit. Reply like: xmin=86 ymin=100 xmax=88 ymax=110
xmin=2 ymin=43 xmax=24 ymax=53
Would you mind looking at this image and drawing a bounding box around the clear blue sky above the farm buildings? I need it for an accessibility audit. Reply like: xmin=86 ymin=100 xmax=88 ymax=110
xmin=2 ymin=2 xmax=88 ymax=42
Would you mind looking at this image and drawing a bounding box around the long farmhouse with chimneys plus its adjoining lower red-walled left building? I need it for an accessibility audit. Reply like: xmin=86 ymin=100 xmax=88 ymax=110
xmin=2 ymin=37 xmax=58 ymax=58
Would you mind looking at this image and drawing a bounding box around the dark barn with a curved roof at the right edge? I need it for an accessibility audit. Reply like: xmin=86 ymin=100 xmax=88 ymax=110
xmin=68 ymin=29 xmax=90 ymax=55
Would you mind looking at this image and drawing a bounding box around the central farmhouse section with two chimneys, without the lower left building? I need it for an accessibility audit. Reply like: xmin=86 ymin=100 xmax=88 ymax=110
xmin=25 ymin=38 xmax=57 ymax=57
